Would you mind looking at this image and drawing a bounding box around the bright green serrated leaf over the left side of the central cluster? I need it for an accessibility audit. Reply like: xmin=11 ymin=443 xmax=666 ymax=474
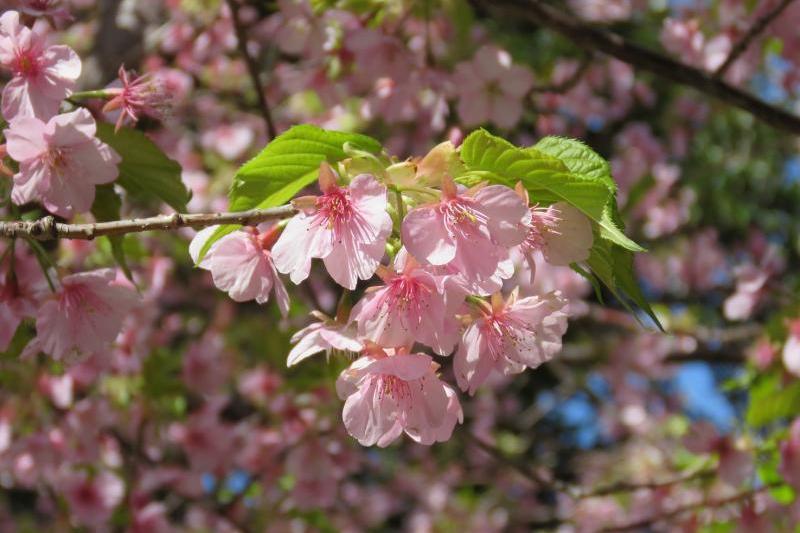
xmin=199 ymin=124 xmax=381 ymax=259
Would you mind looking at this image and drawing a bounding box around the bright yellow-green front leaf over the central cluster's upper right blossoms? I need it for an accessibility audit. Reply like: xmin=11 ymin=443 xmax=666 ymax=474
xmin=461 ymin=129 xmax=611 ymax=223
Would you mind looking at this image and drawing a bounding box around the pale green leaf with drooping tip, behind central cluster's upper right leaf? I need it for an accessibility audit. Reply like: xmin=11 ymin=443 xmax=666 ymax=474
xmin=528 ymin=137 xmax=645 ymax=252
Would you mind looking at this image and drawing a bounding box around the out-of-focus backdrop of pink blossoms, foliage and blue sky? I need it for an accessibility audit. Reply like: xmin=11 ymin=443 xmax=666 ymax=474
xmin=0 ymin=0 xmax=800 ymax=532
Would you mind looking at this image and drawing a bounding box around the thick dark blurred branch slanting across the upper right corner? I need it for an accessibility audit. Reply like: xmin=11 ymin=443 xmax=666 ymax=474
xmin=472 ymin=0 xmax=800 ymax=135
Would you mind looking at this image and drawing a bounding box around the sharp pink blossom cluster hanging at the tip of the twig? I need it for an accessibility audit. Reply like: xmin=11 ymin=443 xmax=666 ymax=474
xmin=191 ymin=143 xmax=593 ymax=446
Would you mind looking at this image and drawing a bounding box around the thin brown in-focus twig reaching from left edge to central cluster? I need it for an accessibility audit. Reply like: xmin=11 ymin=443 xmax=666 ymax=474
xmin=0 ymin=205 xmax=297 ymax=241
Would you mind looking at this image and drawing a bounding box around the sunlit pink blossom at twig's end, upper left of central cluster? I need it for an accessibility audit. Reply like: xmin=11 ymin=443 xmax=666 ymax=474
xmin=272 ymin=163 xmax=392 ymax=290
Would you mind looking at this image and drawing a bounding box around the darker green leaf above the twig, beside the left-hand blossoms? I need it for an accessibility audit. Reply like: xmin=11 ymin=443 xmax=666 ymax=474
xmin=97 ymin=122 xmax=191 ymax=212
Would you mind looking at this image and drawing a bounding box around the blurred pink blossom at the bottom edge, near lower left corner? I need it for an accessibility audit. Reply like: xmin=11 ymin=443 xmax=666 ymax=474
xmin=62 ymin=471 xmax=125 ymax=529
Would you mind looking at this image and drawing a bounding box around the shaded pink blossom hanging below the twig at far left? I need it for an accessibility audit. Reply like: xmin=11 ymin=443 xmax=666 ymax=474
xmin=34 ymin=269 xmax=137 ymax=359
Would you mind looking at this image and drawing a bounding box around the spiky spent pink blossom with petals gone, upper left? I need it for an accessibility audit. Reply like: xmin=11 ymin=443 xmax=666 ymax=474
xmin=103 ymin=67 xmax=170 ymax=131
